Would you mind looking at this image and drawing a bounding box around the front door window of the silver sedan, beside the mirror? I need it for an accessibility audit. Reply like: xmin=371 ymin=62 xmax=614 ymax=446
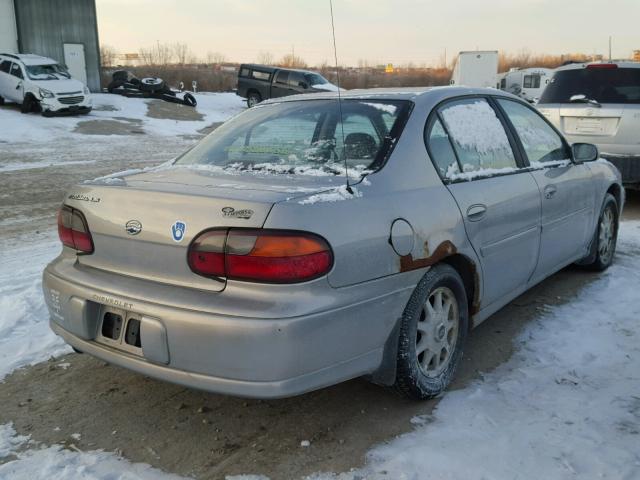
xmin=498 ymin=98 xmax=570 ymax=167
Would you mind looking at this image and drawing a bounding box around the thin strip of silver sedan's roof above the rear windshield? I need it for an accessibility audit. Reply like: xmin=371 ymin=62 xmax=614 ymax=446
xmin=262 ymin=85 xmax=521 ymax=108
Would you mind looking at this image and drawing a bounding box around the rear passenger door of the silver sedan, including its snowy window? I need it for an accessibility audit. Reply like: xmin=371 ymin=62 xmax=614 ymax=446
xmin=427 ymin=97 xmax=540 ymax=307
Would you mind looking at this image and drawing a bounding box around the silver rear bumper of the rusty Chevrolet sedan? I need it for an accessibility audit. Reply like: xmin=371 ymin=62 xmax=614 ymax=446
xmin=43 ymin=259 xmax=413 ymax=398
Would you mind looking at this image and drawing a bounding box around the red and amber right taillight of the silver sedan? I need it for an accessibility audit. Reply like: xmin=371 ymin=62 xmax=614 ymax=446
xmin=188 ymin=228 xmax=333 ymax=283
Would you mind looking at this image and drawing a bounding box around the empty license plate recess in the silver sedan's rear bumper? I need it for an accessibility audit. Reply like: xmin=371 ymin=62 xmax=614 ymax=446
xmin=96 ymin=306 xmax=143 ymax=356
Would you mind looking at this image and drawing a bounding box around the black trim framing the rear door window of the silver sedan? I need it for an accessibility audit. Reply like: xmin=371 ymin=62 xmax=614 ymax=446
xmin=422 ymin=94 xmax=530 ymax=185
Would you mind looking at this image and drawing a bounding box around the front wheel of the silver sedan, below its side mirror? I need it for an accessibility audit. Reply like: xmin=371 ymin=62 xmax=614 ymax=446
xmin=582 ymin=193 xmax=619 ymax=272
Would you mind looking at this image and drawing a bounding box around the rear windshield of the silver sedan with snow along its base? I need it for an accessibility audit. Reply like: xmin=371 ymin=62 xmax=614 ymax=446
xmin=177 ymin=99 xmax=411 ymax=175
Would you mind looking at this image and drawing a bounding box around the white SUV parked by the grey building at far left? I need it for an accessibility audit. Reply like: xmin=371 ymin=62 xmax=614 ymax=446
xmin=0 ymin=53 xmax=92 ymax=116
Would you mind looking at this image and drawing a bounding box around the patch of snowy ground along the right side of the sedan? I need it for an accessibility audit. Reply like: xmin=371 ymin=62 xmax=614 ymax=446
xmin=310 ymin=222 xmax=640 ymax=480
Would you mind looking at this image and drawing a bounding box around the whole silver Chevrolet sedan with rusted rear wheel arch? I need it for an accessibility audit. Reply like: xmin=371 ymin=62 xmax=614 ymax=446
xmin=44 ymin=87 xmax=624 ymax=399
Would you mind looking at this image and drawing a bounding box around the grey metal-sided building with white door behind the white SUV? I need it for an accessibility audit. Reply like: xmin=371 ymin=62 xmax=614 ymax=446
xmin=0 ymin=0 xmax=100 ymax=92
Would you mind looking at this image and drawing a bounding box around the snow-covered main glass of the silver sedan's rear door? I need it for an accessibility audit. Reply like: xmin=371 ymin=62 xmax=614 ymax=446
xmin=439 ymin=98 xmax=517 ymax=178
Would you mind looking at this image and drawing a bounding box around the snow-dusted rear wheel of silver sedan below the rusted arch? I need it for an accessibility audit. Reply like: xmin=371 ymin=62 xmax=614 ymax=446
xmin=394 ymin=264 xmax=469 ymax=400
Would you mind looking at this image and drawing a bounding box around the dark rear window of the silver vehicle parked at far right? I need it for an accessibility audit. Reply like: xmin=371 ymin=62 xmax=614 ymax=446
xmin=538 ymin=68 xmax=640 ymax=104
